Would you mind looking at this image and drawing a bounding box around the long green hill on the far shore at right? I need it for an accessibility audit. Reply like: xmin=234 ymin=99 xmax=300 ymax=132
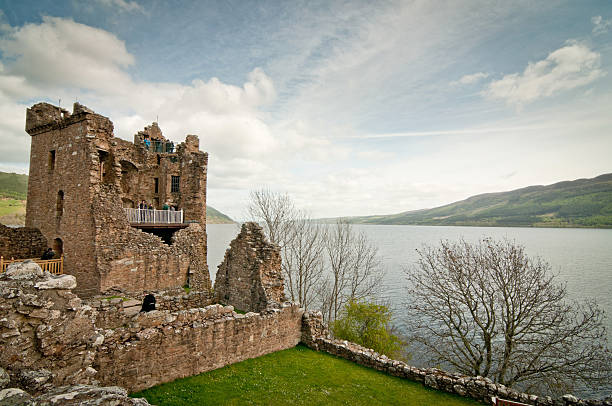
xmin=348 ymin=173 xmax=612 ymax=228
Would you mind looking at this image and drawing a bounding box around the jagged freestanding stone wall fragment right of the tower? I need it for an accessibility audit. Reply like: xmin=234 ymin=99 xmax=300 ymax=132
xmin=215 ymin=223 xmax=285 ymax=312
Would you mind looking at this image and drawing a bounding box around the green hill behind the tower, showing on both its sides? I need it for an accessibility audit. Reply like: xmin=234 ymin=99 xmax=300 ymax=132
xmin=0 ymin=172 xmax=234 ymax=225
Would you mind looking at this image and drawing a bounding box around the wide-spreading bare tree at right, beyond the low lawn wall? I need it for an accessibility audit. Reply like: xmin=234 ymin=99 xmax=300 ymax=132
xmin=406 ymin=239 xmax=612 ymax=395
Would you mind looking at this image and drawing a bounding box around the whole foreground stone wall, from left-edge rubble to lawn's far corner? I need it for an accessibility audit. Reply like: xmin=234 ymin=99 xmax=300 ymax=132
xmin=0 ymin=262 xmax=303 ymax=395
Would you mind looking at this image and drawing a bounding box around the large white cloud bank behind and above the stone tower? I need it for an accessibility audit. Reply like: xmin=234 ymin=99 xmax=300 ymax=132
xmin=0 ymin=17 xmax=280 ymax=181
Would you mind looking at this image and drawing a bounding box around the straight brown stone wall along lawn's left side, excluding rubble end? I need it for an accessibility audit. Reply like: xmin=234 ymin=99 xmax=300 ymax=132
xmin=94 ymin=303 xmax=303 ymax=391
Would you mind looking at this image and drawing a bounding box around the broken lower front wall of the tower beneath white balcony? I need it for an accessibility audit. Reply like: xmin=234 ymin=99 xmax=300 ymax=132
xmin=94 ymin=185 xmax=211 ymax=293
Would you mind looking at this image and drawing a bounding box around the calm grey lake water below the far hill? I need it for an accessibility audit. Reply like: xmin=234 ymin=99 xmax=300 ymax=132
xmin=207 ymin=224 xmax=612 ymax=397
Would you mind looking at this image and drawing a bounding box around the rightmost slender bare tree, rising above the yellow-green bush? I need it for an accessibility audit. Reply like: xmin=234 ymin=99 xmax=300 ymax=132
xmin=319 ymin=220 xmax=383 ymax=322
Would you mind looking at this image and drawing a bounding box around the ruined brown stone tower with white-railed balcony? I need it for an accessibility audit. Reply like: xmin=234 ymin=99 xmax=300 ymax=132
xmin=26 ymin=103 xmax=210 ymax=296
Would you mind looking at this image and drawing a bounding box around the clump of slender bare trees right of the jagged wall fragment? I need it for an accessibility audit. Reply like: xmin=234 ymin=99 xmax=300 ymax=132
xmin=248 ymin=189 xmax=382 ymax=321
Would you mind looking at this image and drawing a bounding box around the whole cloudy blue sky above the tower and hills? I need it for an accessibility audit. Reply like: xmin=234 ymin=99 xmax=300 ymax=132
xmin=0 ymin=0 xmax=612 ymax=218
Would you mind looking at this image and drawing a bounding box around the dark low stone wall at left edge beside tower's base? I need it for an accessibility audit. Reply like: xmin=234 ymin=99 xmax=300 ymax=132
xmin=0 ymin=224 xmax=47 ymax=259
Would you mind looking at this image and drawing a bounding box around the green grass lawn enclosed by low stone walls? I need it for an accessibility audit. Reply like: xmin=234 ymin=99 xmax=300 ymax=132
xmin=131 ymin=346 xmax=480 ymax=406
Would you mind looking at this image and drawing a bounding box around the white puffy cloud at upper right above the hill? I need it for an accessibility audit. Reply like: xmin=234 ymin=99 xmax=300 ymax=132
xmin=483 ymin=42 xmax=605 ymax=107
